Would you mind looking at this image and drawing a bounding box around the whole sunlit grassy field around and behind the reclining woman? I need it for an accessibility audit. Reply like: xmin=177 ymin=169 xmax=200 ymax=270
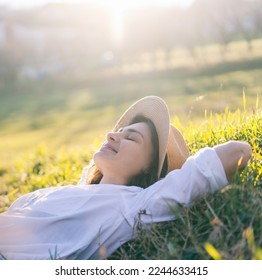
xmin=0 ymin=38 xmax=262 ymax=259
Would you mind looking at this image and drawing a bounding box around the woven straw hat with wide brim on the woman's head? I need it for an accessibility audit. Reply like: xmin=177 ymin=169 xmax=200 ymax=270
xmin=113 ymin=96 xmax=189 ymax=178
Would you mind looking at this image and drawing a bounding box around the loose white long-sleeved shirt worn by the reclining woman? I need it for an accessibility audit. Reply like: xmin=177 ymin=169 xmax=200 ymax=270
xmin=0 ymin=148 xmax=228 ymax=259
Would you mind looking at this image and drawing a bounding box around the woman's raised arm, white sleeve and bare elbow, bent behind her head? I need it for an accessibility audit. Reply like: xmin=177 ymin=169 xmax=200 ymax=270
xmin=134 ymin=141 xmax=252 ymax=223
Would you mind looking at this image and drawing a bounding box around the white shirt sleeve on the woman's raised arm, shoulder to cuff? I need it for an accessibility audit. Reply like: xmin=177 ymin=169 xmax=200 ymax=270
xmin=133 ymin=147 xmax=228 ymax=223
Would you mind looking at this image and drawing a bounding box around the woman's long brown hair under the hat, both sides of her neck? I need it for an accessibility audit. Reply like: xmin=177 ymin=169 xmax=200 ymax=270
xmin=86 ymin=115 xmax=159 ymax=188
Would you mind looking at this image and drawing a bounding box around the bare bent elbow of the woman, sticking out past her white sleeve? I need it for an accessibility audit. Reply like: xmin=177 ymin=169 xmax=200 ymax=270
xmin=214 ymin=141 xmax=252 ymax=181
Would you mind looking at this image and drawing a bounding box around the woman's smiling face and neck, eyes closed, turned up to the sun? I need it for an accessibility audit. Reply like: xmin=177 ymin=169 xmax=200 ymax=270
xmin=93 ymin=122 xmax=153 ymax=185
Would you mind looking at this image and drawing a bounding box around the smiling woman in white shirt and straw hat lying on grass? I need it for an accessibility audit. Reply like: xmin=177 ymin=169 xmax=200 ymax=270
xmin=0 ymin=96 xmax=251 ymax=259
